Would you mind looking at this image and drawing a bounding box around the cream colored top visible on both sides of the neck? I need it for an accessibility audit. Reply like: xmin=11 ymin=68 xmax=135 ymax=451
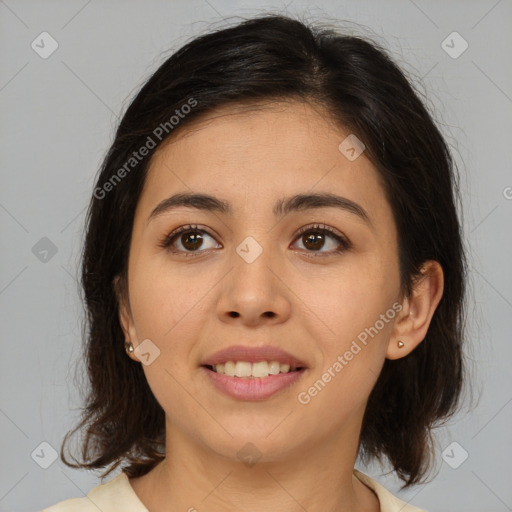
xmin=41 ymin=469 xmax=426 ymax=512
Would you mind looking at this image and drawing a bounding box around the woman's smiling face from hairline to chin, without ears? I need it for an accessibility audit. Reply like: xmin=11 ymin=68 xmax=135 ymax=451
xmin=121 ymin=102 xmax=406 ymax=460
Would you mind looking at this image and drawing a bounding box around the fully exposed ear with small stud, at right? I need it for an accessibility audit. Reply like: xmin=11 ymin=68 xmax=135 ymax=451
xmin=386 ymin=260 xmax=444 ymax=359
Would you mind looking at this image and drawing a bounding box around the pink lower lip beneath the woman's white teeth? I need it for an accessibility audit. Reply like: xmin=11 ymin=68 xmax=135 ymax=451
xmin=201 ymin=366 xmax=306 ymax=400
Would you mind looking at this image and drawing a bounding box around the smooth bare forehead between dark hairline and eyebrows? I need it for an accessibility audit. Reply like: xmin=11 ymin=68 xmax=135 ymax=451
xmin=140 ymin=101 xmax=382 ymax=219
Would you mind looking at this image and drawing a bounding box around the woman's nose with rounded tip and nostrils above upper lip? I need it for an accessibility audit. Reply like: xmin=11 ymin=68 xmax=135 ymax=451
xmin=217 ymin=241 xmax=292 ymax=327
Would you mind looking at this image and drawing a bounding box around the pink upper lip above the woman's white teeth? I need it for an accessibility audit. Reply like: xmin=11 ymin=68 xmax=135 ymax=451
xmin=202 ymin=345 xmax=306 ymax=368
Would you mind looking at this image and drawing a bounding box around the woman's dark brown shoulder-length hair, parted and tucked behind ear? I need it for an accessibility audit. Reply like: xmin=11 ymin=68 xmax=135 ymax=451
xmin=61 ymin=14 xmax=466 ymax=487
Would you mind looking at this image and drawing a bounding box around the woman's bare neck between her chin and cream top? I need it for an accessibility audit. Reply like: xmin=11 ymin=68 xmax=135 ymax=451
xmin=131 ymin=418 xmax=380 ymax=512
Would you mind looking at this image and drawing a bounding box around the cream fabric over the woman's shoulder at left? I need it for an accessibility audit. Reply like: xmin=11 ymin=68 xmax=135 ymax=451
xmin=41 ymin=473 xmax=148 ymax=512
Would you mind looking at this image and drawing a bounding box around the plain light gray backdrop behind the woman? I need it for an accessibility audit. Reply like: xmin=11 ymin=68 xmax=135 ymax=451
xmin=0 ymin=0 xmax=512 ymax=512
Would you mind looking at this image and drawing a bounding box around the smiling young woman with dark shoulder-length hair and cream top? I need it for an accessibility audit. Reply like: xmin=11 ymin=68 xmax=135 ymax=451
xmin=46 ymin=15 xmax=466 ymax=512
